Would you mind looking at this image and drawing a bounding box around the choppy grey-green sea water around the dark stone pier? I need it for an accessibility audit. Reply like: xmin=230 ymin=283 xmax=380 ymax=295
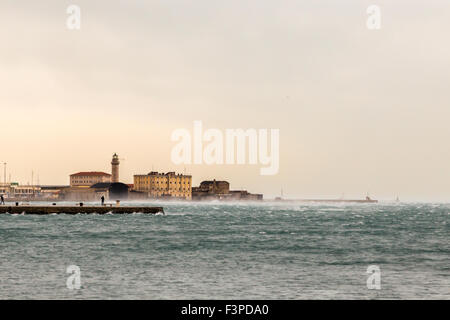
xmin=0 ymin=203 xmax=450 ymax=299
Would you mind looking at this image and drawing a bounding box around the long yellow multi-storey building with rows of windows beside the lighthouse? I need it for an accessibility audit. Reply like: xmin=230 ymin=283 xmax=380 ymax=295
xmin=134 ymin=171 xmax=192 ymax=200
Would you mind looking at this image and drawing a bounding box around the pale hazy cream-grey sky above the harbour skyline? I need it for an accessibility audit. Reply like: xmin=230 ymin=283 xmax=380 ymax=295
xmin=0 ymin=0 xmax=450 ymax=201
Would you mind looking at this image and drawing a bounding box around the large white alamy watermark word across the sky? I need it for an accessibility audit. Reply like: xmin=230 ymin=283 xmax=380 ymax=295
xmin=171 ymin=121 xmax=280 ymax=175
